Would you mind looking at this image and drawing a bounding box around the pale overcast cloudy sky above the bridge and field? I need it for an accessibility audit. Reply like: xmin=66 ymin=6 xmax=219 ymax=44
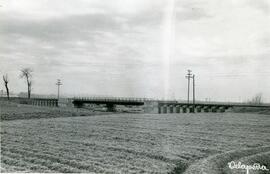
xmin=0 ymin=0 xmax=270 ymax=102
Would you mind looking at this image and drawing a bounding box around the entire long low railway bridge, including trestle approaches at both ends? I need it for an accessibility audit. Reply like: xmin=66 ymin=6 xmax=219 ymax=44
xmin=0 ymin=97 xmax=270 ymax=114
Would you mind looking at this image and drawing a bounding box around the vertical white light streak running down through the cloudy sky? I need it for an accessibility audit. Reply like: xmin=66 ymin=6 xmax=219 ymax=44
xmin=162 ymin=0 xmax=175 ymax=99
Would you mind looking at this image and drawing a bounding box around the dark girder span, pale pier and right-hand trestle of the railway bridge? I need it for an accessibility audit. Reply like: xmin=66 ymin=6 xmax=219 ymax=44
xmin=72 ymin=97 xmax=270 ymax=113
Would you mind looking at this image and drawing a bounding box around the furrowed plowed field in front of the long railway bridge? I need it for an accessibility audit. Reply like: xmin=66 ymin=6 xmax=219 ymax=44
xmin=1 ymin=109 xmax=270 ymax=173
